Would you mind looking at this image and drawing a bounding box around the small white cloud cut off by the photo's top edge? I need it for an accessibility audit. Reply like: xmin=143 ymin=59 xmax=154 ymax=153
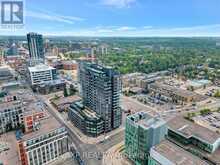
xmin=102 ymin=0 xmax=136 ymax=8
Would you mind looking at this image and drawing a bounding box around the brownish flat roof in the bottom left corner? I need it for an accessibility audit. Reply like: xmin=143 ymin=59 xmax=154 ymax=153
xmin=0 ymin=132 xmax=21 ymax=165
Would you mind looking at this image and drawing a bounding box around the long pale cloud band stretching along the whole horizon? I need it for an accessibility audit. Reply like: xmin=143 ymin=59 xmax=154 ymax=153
xmin=0 ymin=24 xmax=220 ymax=37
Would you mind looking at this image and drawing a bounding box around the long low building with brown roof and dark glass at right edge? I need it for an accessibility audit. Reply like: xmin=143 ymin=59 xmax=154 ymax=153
xmin=168 ymin=116 xmax=220 ymax=153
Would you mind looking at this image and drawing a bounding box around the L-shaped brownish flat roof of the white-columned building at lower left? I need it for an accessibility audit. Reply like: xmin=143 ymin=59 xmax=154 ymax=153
xmin=21 ymin=114 xmax=62 ymax=141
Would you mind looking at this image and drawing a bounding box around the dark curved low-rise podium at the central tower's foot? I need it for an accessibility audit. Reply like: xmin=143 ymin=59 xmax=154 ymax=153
xmin=68 ymin=101 xmax=104 ymax=137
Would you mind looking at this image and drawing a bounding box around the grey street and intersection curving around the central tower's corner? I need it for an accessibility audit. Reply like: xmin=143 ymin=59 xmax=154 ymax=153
xmin=38 ymin=96 xmax=124 ymax=165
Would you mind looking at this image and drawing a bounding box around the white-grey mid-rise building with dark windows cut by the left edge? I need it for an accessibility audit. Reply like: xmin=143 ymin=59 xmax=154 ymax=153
xmin=0 ymin=99 xmax=24 ymax=134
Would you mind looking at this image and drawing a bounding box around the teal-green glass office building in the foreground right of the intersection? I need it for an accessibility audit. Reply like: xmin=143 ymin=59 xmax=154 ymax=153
xmin=125 ymin=112 xmax=167 ymax=165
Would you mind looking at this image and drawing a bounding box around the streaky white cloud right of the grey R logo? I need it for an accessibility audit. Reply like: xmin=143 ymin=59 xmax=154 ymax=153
xmin=25 ymin=11 xmax=85 ymax=24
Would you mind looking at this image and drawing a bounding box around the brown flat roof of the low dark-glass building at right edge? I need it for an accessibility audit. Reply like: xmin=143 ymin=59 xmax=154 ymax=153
xmin=168 ymin=116 xmax=220 ymax=144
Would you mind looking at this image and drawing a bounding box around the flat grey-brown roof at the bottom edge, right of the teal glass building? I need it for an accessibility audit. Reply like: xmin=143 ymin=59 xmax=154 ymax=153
xmin=152 ymin=140 xmax=208 ymax=165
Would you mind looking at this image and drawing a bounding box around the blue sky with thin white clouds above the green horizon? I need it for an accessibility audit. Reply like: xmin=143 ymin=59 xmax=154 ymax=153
xmin=0 ymin=0 xmax=220 ymax=37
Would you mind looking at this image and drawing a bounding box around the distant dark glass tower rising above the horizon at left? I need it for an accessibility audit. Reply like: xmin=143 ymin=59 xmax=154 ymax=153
xmin=27 ymin=33 xmax=45 ymax=65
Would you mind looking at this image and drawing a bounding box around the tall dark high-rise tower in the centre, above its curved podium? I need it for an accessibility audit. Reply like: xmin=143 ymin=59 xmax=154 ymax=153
xmin=78 ymin=62 xmax=122 ymax=132
